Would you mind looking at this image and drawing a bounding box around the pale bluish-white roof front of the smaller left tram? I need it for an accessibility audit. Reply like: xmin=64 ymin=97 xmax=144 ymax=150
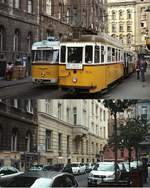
xmin=32 ymin=40 xmax=60 ymax=50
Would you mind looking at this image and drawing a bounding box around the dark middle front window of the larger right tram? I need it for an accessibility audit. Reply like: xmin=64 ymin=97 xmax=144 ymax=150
xmin=68 ymin=47 xmax=83 ymax=63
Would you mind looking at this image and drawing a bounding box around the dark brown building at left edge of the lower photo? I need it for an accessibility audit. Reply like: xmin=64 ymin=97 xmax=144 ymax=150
xmin=0 ymin=99 xmax=38 ymax=170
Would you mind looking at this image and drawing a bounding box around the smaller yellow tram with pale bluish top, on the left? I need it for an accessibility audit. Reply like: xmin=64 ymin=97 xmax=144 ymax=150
xmin=32 ymin=37 xmax=60 ymax=86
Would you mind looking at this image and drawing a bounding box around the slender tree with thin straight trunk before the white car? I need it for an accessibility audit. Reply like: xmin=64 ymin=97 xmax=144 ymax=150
xmin=103 ymin=99 xmax=137 ymax=182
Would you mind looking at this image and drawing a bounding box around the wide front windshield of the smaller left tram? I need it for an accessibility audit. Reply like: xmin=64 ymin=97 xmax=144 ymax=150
xmin=33 ymin=50 xmax=59 ymax=63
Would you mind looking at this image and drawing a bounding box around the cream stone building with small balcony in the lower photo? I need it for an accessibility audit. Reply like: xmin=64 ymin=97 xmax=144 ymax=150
xmin=38 ymin=100 xmax=108 ymax=164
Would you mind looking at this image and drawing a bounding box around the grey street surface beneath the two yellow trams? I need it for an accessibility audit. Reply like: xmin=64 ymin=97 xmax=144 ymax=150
xmin=0 ymin=69 xmax=150 ymax=99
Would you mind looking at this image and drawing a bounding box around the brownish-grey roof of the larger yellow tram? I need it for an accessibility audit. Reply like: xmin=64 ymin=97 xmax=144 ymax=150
xmin=62 ymin=33 xmax=123 ymax=48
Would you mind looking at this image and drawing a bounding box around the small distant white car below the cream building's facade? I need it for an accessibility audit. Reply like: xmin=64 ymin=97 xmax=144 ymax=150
xmin=71 ymin=162 xmax=86 ymax=175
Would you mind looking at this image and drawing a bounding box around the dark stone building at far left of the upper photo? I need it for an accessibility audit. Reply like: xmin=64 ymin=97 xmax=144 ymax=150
xmin=0 ymin=0 xmax=39 ymax=78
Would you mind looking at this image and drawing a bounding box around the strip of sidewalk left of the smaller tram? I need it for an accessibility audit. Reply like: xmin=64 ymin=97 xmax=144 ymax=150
xmin=0 ymin=77 xmax=32 ymax=89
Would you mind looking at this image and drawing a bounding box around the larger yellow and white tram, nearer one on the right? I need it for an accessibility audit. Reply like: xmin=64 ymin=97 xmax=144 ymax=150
xmin=59 ymin=34 xmax=133 ymax=93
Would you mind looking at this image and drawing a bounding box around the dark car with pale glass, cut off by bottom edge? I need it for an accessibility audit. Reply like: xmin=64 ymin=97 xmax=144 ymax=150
xmin=3 ymin=171 xmax=78 ymax=188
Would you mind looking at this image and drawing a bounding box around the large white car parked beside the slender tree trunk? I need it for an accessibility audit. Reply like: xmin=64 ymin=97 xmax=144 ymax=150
xmin=88 ymin=162 xmax=121 ymax=186
